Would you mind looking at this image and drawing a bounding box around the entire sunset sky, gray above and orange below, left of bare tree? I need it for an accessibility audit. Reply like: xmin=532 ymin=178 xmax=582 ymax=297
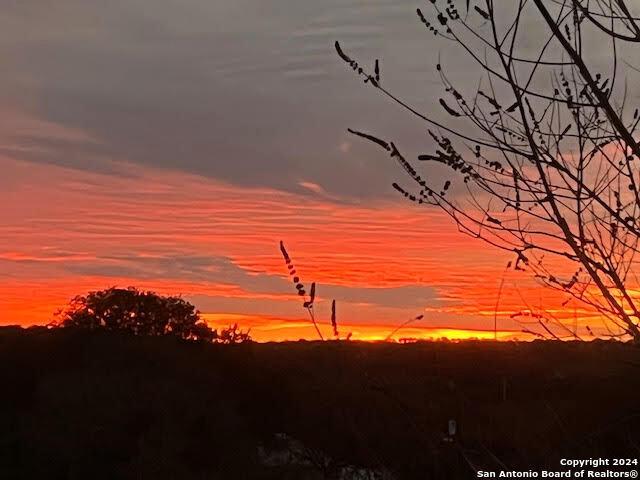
xmin=0 ymin=0 xmax=624 ymax=340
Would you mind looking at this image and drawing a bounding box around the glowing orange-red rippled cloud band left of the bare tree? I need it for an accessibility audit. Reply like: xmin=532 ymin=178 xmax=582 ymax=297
xmin=0 ymin=158 xmax=608 ymax=339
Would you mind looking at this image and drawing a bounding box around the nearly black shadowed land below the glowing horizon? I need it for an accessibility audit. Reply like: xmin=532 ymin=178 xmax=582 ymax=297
xmin=0 ymin=328 xmax=640 ymax=479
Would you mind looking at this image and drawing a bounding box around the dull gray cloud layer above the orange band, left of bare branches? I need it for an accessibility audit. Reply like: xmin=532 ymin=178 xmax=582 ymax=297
xmin=0 ymin=0 xmax=637 ymax=199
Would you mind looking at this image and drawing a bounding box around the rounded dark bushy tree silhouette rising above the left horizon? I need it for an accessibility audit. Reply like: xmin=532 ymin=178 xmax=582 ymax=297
xmin=58 ymin=287 xmax=218 ymax=341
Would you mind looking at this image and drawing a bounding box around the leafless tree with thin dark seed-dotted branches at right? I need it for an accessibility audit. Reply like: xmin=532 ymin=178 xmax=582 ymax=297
xmin=335 ymin=0 xmax=640 ymax=341
